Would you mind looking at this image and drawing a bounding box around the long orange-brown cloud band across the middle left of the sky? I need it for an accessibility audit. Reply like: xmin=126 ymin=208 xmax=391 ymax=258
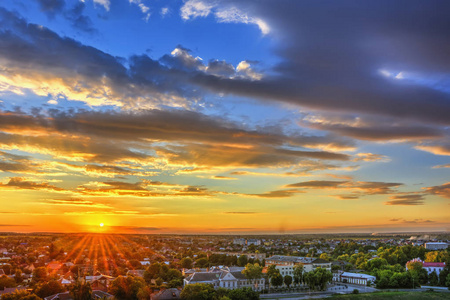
xmin=0 ymin=109 xmax=351 ymax=171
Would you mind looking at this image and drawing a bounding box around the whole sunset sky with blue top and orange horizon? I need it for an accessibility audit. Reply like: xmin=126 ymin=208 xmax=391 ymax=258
xmin=0 ymin=0 xmax=450 ymax=235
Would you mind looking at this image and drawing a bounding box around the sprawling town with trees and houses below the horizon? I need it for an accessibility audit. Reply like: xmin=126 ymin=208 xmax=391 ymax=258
xmin=0 ymin=233 xmax=450 ymax=300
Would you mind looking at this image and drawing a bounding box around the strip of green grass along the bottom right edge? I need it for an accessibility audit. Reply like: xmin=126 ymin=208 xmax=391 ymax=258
xmin=330 ymin=292 xmax=450 ymax=300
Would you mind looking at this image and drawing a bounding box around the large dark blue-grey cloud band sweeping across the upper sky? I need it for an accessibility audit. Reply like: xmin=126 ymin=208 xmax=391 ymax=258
xmin=0 ymin=1 xmax=450 ymax=126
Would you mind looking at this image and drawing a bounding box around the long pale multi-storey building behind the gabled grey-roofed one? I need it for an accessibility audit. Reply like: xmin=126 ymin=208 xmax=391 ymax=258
xmin=266 ymin=255 xmax=331 ymax=276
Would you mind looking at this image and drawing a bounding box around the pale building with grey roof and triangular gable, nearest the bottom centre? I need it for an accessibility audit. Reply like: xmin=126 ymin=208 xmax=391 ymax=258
xmin=183 ymin=269 xmax=265 ymax=291
